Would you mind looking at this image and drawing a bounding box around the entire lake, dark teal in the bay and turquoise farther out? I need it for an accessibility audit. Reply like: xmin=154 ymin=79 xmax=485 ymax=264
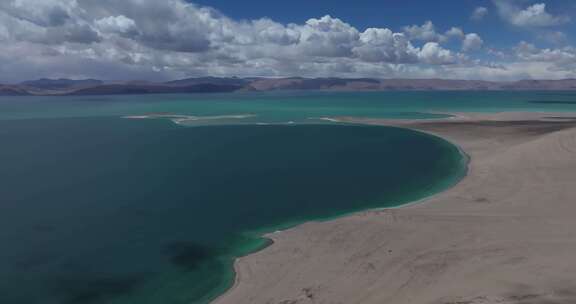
xmin=0 ymin=92 xmax=574 ymax=304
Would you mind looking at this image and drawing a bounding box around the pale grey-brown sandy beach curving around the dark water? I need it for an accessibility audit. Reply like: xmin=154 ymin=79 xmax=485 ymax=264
xmin=214 ymin=113 xmax=576 ymax=304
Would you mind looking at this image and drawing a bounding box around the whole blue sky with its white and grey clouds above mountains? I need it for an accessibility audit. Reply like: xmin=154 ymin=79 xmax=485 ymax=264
xmin=0 ymin=0 xmax=576 ymax=83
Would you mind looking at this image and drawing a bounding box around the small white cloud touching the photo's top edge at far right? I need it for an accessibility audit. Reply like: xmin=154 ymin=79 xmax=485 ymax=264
xmin=493 ymin=0 xmax=570 ymax=27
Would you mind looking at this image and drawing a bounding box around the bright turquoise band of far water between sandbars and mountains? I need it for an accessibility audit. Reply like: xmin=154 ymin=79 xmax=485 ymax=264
xmin=0 ymin=92 xmax=576 ymax=123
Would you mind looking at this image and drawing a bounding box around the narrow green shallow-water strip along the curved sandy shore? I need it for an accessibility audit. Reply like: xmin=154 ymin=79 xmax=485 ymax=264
xmin=206 ymin=123 xmax=472 ymax=303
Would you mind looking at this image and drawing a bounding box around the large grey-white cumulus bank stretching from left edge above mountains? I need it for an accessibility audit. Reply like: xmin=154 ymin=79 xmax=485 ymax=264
xmin=0 ymin=0 xmax=568 ymax=81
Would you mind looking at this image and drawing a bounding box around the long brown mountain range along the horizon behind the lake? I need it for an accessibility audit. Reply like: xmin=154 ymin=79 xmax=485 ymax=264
xmin=0 ymin=77 xmax=576 ymax=95
